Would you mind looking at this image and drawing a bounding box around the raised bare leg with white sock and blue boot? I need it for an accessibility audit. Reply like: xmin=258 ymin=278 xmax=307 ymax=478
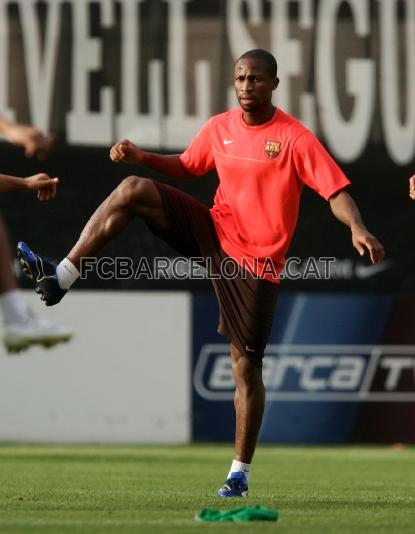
xmin=17 ymin=176 xmax=167 ymax=306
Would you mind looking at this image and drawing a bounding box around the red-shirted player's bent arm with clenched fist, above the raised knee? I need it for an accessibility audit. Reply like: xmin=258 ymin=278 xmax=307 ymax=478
xmin=110 ymin=139 xmax=195 ymax=180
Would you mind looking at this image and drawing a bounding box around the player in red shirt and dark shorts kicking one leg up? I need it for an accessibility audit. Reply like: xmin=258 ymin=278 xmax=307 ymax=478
xmin=18 ymin=49 xmax=384 ymax=497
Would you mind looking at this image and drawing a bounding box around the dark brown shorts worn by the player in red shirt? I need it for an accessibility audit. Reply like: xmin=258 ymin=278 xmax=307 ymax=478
xmin=147 ymin=182 xmax=278 ymax=367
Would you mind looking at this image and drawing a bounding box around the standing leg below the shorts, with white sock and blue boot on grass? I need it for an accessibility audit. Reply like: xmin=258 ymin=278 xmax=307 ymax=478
xmin=218 ymin=345 xmax=265 ymax=497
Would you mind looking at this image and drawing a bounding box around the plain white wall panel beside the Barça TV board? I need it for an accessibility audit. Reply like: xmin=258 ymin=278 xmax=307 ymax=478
xmin=0 ymin=291 xmax=191 ymax=443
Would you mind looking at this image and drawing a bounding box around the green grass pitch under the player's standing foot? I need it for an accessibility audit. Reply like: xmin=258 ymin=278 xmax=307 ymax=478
xmin=0 ymin=445 xmax=415 ymax=534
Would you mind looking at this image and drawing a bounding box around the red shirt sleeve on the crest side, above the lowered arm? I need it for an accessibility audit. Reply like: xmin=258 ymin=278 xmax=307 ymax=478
xmin=293 ymin=131 xmax=350 ymax=200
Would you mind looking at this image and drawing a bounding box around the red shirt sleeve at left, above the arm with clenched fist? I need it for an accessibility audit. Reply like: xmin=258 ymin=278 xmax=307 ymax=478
xmin=180 ymin=119 xmax=215 ymax=176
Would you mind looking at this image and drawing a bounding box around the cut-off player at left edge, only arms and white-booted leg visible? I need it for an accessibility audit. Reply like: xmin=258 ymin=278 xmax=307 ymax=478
xmin=0 ymin=117 xmax=73 ymax=352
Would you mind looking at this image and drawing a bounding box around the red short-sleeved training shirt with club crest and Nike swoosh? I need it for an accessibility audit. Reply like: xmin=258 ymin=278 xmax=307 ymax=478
xmin=180 ymin=108 xmax=350 ymax=283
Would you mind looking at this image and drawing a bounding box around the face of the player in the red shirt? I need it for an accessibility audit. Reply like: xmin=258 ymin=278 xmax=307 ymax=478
xmin=234 ymin=58 xmax=279 ymax=112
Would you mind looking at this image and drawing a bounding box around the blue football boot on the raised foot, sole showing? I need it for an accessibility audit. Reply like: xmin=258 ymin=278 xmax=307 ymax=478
xmin=17 ymin=241 xmax=67 ymax=306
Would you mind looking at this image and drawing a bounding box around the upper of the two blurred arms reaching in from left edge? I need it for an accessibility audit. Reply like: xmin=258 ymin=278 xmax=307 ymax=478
xmin=0 ymin=116 xmax=55 ymax=159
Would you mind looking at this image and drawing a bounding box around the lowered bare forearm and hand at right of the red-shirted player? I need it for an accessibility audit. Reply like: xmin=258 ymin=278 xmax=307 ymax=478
xmin=329 ymin=189 xmax=385 ymax=263
